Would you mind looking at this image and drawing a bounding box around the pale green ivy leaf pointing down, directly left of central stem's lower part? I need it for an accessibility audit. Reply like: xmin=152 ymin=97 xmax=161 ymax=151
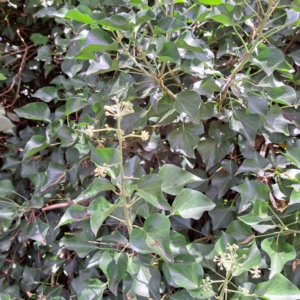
xmin=87 ymin=197 xmax=119 ymax=236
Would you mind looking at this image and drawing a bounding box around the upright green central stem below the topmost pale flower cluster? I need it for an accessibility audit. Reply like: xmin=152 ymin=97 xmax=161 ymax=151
xmin=116 ymin=115 xmax=132 ymax=235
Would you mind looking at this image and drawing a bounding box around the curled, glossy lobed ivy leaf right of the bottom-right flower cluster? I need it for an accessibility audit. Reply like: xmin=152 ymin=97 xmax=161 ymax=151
xmin=261 ymin=237 xmax=296 ymax=278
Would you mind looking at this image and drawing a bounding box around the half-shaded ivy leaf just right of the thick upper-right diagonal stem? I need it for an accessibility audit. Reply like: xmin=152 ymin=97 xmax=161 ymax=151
xmin=253 ymin=47 xmax=285 ymax=76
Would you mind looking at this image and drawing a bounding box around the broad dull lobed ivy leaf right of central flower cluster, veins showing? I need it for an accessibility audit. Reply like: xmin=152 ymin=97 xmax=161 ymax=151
xmin=168 ymin=123 xmax=204 ymax=158
